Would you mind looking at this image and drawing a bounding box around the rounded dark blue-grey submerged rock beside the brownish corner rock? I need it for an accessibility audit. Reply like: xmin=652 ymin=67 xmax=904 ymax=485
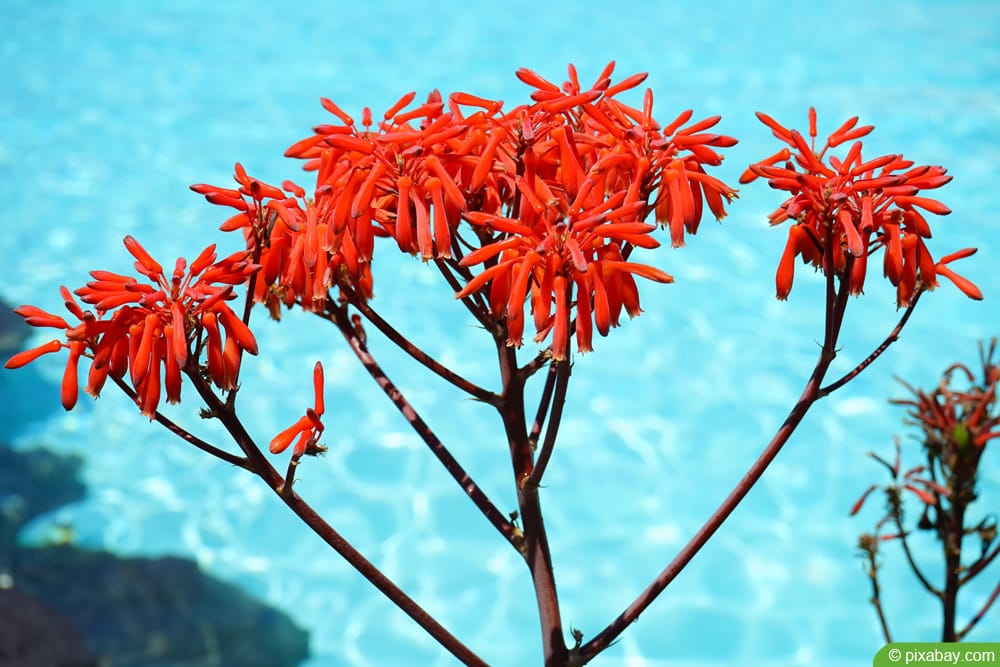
xmin=13 ymin=545 xmax=308 ymax=667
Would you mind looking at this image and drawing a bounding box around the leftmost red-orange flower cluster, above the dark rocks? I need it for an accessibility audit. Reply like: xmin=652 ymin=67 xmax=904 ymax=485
xmin=6 ymin=236 xmax=258 ymax=418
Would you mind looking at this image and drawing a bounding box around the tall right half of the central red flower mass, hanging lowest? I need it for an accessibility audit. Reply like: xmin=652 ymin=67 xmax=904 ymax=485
xmin=452 ymin=63 xmax=736 ymax=360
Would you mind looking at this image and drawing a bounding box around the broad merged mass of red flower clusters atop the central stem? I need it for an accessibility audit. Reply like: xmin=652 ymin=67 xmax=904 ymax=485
xmin=193 ymin=63 xmax=736 ymax=359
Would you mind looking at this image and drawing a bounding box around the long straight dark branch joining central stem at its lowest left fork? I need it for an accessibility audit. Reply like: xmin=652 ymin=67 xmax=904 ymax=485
xmin=326 ymin=305 xmax=523 ymax=553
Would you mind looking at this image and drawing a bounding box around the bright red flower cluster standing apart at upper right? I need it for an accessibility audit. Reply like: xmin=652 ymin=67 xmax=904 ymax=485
xmin=740 ymin=109 xmax=982 ymax=307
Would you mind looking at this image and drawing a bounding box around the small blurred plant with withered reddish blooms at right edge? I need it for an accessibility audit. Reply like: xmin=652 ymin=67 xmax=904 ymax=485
xmin=851 ymin=338 xmax=1000 ymax=643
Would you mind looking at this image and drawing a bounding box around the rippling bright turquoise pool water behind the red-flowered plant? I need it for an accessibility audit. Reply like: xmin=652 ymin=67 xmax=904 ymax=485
xmin=0 ymin=0 xmax=1000 ymax=667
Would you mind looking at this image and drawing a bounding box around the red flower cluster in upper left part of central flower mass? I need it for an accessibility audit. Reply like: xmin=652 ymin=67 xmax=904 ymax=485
xmin=285 ymin=91 xmax=468 ymax=262
